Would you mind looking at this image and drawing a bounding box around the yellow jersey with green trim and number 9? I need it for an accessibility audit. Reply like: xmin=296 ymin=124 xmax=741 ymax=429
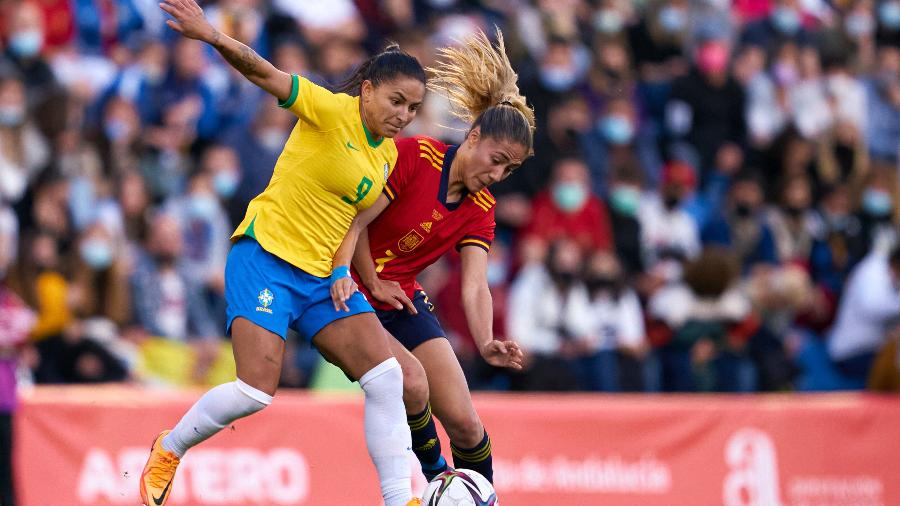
xmin=231 ymin=75 xmax=397 ymax=277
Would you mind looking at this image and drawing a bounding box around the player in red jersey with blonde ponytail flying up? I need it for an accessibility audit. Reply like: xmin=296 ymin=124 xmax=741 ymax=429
xmin=332 ymin=30 xmax=534 ymax=486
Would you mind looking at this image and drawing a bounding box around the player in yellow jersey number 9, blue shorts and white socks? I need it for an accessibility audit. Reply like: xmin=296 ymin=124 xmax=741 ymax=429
xmin=140 ymin=0 xmax=426 ymax=506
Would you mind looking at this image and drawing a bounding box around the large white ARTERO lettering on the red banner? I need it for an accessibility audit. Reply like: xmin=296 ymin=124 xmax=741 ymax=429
xmin=72 ymin=448 xmax=310 ymax=505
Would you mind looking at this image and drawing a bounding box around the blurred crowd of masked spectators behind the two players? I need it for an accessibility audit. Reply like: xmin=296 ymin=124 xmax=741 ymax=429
xmin=0 ymin=0 xmax=900 ymax=392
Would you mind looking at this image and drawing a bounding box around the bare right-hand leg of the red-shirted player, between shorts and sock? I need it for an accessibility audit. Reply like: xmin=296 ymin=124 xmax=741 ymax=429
xmin=412 ymin=338 xmax=484 ymax=445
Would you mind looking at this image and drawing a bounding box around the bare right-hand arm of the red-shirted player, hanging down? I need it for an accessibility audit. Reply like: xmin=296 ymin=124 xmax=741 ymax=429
xmin=459 ymin=246 xmax=523 ymax=369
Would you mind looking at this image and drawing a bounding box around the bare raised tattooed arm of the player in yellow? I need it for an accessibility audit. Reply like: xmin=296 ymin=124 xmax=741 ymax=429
xmin=159 ymin=0 xmax=291 ymax=101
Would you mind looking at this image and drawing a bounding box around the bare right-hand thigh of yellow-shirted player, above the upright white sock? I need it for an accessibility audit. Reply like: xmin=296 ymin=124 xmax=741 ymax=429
xmin=312 ymin=312 xmax=393 ymax=381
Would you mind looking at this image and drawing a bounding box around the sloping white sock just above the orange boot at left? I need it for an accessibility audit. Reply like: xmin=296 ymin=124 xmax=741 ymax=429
xmin=162 ymin=379 xmax=272 ymax=458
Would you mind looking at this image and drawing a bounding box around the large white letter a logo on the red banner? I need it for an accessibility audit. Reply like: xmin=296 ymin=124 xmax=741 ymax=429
xmin=722 ymin=428 xmax=782 ymax=506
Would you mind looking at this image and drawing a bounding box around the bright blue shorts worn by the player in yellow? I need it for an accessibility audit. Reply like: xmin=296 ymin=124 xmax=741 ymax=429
xmin=225 ymin=237 xmax=374 ymax=341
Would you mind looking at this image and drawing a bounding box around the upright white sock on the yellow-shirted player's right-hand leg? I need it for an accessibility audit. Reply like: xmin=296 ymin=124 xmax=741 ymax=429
xmin=359 ymin=357 xmax=412 ymax=506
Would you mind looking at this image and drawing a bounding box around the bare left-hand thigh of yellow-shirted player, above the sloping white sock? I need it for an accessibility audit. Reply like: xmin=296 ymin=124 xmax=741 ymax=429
xmin=231 ymin=317 xmax=284 ymax=395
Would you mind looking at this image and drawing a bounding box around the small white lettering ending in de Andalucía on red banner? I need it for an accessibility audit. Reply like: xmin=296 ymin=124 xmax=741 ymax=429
xmin=494 ymin=455 xmax=672 ymax=494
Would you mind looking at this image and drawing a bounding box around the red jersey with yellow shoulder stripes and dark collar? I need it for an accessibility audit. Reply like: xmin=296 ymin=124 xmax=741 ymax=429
xmin=353 ymin=136 xmax=496 ymax=309
